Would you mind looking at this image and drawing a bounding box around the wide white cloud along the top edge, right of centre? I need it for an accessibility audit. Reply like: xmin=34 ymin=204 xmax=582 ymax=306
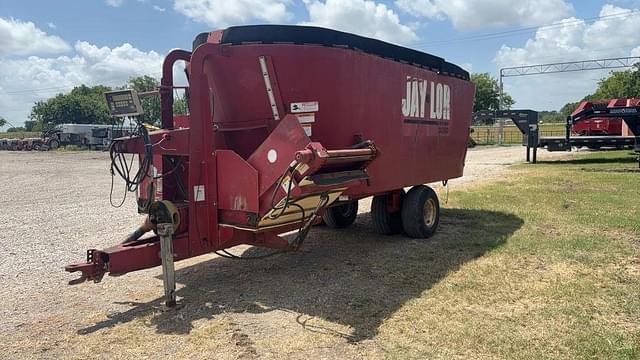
xmin=395 ymin=0 xmax=573 ymax=31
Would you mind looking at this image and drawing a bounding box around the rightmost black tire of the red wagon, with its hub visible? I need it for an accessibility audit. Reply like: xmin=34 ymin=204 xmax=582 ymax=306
xmin=402 ymin=185 xmax=440 ymax=239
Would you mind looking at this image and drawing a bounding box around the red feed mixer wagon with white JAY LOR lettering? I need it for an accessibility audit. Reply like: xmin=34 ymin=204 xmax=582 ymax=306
xmin=66 ymin=25 xmax=474 ymax=305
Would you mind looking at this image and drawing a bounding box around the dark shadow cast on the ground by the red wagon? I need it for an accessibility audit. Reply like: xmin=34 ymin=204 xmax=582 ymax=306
xmin=78 ymin=209 xmax=523 ymax=342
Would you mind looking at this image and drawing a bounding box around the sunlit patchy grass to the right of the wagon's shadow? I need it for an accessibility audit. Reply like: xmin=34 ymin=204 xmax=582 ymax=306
xmin=384 ymin=151 xmax=640 ymax=359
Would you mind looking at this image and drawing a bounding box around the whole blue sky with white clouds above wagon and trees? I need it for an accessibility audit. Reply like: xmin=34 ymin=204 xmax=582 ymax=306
xmin=0 ymin=0 xmax=640 ymax=124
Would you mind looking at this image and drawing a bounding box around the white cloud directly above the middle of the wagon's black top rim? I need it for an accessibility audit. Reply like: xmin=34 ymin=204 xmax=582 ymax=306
xmin=305 ymin=0 xmax=418 ymax=44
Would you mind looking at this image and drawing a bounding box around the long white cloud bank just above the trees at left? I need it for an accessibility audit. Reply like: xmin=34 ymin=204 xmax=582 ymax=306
xmin=0 ymin=41 xmax=170 ymax=126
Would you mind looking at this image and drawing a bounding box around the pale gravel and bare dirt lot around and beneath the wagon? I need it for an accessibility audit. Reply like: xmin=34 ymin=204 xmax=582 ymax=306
xmin=0 ymin=146 xmax=567 ymax=359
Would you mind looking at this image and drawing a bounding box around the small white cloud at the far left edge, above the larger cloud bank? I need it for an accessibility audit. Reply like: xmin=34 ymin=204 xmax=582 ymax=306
xmin=0 ymin=18 xmax=71 ymax=57
